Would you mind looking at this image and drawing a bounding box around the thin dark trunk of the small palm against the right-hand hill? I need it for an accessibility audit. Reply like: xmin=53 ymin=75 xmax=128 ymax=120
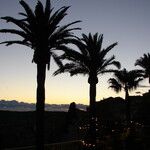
xmin=125 ymin=88 xmax=131 ymax=125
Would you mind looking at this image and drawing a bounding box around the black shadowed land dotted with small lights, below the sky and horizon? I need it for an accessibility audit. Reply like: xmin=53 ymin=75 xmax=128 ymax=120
xmin=0 ymin=93 xmax=150 ymax=150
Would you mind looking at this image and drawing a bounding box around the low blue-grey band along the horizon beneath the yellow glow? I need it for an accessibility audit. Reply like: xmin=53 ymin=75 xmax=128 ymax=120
xmin=0 ymin=100 xmax=87 ymax=112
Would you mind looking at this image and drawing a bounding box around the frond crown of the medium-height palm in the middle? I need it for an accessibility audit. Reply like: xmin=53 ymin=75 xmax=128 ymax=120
xmin=54 ymin=33 xmax=120 ymax=75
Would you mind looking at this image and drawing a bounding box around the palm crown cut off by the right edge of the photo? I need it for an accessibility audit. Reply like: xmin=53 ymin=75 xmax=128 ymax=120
xmin=135 ymin=53 xmax=150 ymax=84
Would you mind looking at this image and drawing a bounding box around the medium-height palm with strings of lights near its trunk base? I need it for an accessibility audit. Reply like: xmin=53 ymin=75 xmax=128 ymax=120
xmin=54 ymin=33 xmax=120 ymax=144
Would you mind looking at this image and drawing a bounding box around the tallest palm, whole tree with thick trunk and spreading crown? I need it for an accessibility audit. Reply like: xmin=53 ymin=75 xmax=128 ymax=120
xmin=0 ymin=0 xmax=80 ymax=150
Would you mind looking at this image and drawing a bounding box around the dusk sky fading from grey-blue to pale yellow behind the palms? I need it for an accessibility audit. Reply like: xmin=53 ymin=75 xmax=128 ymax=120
xmin=0 ymin=0 xmax=150 ymax=104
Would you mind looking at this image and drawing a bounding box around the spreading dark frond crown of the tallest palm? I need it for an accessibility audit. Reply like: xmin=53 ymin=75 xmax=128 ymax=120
xmin=0 ymin=0 xmax=80 ymax=68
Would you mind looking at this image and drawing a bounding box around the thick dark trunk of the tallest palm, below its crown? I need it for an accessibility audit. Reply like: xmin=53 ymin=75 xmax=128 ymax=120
xmin=36 ymin=63 xmax=46 ymax=150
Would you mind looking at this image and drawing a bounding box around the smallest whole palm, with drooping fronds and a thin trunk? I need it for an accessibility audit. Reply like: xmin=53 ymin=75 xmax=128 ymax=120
xmin=108 ymin=68 xmax=143 ymax=123
